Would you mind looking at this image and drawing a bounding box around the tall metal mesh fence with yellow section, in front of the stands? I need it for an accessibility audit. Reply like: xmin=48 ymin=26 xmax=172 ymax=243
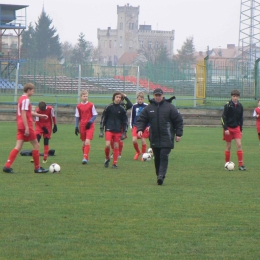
xmin=0 ymin=58 xmax=260 ymax=100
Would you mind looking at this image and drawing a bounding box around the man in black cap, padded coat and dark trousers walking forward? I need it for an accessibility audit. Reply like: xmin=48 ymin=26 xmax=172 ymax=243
xmin=137 ymin=88 xmax=183 ymax=185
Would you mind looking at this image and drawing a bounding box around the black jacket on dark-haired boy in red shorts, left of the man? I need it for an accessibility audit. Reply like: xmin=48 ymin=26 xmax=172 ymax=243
xmin=100 ymin=103 xmax=128 ymax=133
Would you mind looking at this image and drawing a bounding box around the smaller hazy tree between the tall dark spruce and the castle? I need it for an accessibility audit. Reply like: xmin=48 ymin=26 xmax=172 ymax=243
xmin=71 ymin=33 xmax=93 ymax=64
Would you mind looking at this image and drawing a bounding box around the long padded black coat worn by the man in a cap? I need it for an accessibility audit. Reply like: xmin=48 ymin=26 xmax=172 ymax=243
xmin=137 ymin=99 xmax=183 ymax=148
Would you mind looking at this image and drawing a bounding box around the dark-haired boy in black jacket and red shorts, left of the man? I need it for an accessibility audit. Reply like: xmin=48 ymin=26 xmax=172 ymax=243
xmin=99 ymin=92 xmax=128 ymax=169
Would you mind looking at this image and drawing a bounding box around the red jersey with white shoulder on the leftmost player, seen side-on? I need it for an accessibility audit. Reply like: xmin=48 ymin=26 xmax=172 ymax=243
xmin=16 ymin=95 xmax=33 ymax=129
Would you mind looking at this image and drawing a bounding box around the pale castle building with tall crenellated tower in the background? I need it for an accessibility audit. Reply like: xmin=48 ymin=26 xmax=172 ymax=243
xmin=97 ymin=4 xmax=174 ymax=65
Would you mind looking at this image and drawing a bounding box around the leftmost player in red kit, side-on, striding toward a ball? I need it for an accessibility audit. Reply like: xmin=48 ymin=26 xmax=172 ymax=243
xmin=3 ymin=83 xmax=48 ymax=173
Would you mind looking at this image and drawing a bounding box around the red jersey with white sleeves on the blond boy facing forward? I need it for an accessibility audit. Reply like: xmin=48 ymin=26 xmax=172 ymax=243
xmin=75 ymin=102 xmax=97 ymax=125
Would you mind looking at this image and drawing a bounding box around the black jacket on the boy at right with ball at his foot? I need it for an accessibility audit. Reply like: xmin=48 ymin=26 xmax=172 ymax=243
xmin=221 ymin=100 xmax=244 ymax=131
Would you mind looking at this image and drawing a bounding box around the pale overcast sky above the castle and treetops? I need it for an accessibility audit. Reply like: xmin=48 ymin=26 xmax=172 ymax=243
xmin=0 ymin=0 xmax=241 ymax=53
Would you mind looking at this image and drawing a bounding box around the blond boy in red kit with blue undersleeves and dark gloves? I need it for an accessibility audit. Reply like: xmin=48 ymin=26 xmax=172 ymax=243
xmin=75 ymin=90 xmax=98 ymax=164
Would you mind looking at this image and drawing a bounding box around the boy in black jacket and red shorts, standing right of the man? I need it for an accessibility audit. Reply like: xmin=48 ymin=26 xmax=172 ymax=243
xmin=221 ymin=89 xmax=246 ymax=171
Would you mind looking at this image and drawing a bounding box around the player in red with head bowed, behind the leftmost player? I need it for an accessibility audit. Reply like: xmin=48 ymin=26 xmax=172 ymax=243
xmin=35 ymin=101 xmax=58 ymax=163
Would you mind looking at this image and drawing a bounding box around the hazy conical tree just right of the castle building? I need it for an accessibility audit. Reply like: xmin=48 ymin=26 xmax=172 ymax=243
xmin=177 ymin=37 xmax=195 ymax=66
